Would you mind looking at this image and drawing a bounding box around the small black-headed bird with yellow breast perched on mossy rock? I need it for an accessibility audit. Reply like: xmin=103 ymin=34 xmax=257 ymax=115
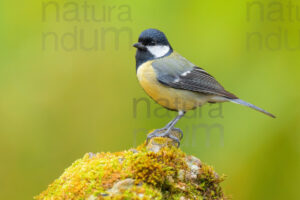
xmin=133 ymin=28 xmax=275 ymax=145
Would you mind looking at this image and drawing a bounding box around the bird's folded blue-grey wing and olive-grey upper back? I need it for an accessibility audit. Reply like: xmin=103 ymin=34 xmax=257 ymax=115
xmin=152 ymin=53 xmax=237 ymax=99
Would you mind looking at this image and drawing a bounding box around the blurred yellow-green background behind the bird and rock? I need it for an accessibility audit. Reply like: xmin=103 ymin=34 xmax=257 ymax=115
xmin=0 ymin=0 xmax=300 ymax=200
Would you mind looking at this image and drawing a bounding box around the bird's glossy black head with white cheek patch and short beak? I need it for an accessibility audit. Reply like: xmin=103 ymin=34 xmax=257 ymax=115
xmin=133 ymin=29 xmax=173 ymax=66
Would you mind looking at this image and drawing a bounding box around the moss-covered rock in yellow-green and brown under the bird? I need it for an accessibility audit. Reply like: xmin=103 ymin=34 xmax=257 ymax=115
xmin=35 ymin=133 xmax=226 ymax=200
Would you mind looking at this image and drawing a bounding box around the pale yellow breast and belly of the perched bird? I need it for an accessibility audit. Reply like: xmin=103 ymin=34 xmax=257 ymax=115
xmin=137 ymin=61 xmax=209 ymax=110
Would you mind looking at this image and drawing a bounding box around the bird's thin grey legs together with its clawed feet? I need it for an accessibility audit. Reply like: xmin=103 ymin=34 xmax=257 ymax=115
xmin=147 ymin=111 xmax=185 ymax=144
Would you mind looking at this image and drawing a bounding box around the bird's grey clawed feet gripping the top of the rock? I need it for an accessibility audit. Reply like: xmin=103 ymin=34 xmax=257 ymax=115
xmin=146 ymin=127 xmax=183 ymax=147
